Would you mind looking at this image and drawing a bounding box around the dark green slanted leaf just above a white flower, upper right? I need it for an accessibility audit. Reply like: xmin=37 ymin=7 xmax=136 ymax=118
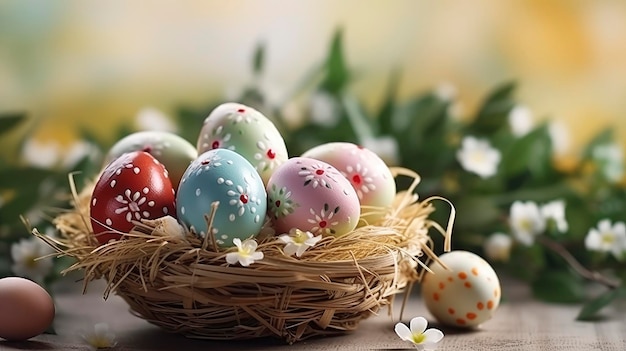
xmin=470 ymin=82 xmax=516 ymax=134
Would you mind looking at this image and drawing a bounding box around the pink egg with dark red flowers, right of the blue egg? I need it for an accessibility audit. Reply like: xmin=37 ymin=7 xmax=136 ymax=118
xmin=267 ymin=157 xmax=361 ymax=236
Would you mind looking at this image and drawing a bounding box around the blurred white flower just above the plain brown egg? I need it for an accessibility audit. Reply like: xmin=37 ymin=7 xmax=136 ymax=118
xmin=11 ymin=236 xmax=54 ymax=283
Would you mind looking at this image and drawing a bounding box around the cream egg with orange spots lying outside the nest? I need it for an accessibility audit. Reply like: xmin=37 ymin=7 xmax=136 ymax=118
xmin=422 ymin=250 xmax=501 ymax=328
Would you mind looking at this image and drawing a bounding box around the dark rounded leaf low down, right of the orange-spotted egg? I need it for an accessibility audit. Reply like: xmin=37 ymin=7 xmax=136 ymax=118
xmin=532 ymin=270 xmax=585 ymax=303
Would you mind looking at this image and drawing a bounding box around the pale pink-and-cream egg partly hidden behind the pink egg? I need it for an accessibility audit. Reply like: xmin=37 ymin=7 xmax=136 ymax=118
xmin=302 ymin=142 xmax=396 ymax=224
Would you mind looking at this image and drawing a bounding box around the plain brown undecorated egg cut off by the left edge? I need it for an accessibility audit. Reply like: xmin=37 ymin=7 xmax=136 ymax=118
xmin=0 ymin=277 xmax=55 ymax=341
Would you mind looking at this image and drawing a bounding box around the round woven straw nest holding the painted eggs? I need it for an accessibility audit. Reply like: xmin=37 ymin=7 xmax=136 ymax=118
xmin=33 ymin=168 xmax=454 ymax=343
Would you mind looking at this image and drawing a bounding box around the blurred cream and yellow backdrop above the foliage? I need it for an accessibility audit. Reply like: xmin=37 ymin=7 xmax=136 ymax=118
xmin=0 ymin=0 xmax=626 ymax=157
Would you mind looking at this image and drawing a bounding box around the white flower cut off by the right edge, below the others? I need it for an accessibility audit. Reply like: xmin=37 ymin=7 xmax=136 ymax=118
xmin=585 ymin=219 xmax=626 ymax=259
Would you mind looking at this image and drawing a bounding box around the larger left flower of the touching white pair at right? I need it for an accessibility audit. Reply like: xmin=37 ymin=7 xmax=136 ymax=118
xmin=509 ymin=201 xmax=546 ymax=246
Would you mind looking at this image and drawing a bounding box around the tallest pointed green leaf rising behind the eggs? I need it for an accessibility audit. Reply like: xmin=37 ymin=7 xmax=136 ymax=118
xmin=321 ymin=29 xmax=350 ymax=94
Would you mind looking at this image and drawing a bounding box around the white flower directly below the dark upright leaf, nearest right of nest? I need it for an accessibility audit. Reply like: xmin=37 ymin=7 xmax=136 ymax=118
xmin=456 ymin=136 xmax=501 ymax=178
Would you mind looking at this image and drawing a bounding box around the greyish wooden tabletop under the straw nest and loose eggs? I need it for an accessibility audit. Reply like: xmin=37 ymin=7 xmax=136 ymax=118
xmin=0 ymin=282 xmax=626 ymax=351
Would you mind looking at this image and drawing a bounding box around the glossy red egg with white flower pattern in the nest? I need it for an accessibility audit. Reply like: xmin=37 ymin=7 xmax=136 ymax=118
xmin=90 ymin=151 xmax=176 ymax=244
